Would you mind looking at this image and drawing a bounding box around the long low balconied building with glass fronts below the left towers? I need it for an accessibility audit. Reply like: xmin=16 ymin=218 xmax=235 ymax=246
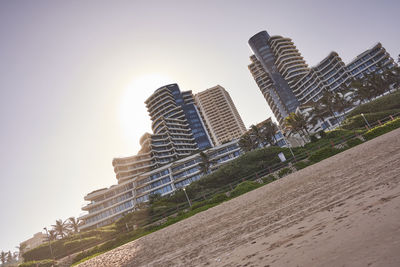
xmin=79 ymin=140 xmax=242 ymax=230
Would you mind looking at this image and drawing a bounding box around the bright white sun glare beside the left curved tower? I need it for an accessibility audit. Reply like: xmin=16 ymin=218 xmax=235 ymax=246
xmin=118 ymin=73 xmax=176 ymax=154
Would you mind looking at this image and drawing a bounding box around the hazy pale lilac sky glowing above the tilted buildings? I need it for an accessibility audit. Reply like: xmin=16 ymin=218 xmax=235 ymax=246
xmin=0 ymin=0 xmax=400 ymax=254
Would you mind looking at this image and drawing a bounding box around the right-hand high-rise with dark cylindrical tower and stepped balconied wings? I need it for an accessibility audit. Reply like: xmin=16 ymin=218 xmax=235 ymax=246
xmin=248 ymin=31 xmax=395 ymax=124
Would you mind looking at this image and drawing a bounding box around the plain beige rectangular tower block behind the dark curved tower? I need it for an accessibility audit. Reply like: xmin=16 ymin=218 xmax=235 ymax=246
xmin=195 ymin=85 xmax=246 ymax=146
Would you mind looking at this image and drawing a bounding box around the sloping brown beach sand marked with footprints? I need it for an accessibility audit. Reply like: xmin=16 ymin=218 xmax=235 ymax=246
xmin=79 ymin=129 xmax=400 ymax=267
